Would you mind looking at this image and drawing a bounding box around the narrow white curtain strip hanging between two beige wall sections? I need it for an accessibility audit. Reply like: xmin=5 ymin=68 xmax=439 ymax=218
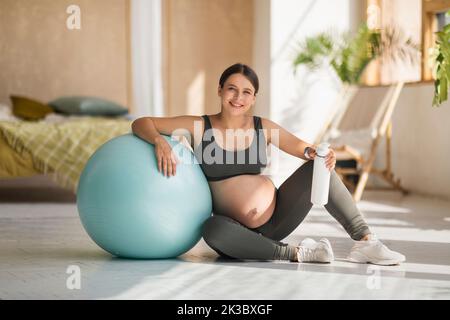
xmin=131 ymin=0 xmax=164 ymax=117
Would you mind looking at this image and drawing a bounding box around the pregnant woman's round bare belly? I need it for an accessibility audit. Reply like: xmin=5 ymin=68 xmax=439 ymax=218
xmin=209 ymin=174 xmax=276 ymax=228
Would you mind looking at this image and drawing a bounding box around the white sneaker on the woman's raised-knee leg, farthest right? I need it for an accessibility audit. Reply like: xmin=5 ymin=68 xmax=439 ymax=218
xmin=348 ymin=234 xmax=406 ymax=266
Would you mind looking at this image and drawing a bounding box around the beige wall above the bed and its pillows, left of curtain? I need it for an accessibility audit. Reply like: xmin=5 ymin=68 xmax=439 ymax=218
xmin=0 ymin=0 xmax=130 ymax=105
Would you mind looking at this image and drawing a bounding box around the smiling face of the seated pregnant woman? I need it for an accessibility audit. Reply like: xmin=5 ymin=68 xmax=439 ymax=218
xmin=219 ymin=73 xmax=256 ymax=115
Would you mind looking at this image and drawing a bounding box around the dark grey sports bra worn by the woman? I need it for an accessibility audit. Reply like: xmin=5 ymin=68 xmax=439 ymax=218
xmin=194 ymin=115 xmax=267 ymax=181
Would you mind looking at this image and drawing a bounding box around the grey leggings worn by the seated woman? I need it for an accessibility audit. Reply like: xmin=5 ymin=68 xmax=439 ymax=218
xmin=203 ymin=161 xmax=370 ymax=260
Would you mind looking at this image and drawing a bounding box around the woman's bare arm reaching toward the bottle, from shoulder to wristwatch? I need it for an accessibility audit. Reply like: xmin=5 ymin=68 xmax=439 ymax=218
xmin=261 ymin=118 xmax=316 ymax=160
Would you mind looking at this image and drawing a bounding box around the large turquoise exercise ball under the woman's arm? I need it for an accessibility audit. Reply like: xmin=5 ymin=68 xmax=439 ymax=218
xmin=77 ymin=134 xmax=212 ymax=259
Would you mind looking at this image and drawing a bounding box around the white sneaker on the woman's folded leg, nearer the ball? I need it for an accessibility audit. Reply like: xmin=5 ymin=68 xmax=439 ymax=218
xmin=297 ymin=238 xmax=334 ymax=263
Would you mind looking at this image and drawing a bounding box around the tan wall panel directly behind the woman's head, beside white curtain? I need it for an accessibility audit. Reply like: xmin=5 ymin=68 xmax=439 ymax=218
xmin=163 ymin=0 xmax=253 ymax=116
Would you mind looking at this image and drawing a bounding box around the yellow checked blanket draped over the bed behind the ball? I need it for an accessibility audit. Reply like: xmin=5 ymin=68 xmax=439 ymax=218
xmin=0 ymin=117 xmax=131 ymax=192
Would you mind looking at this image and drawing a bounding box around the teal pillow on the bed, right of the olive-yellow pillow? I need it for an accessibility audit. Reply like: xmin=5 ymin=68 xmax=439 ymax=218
xmin=48 ymin=96 xmax=128 ymax=116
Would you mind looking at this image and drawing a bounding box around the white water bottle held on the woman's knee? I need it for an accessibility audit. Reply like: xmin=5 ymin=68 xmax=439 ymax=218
xmin=311 ymin=142 xmax=330 ymax=206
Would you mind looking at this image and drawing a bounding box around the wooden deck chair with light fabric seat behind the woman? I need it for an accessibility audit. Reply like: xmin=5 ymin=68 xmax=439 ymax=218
xmin=316 ymin=82 xmax=408 ymax=201
